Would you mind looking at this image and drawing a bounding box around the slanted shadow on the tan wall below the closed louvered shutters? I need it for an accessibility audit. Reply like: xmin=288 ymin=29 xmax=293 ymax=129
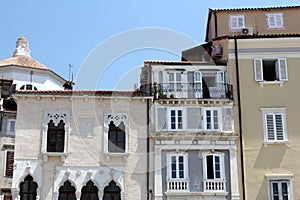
xmin=254 ymin=144 xmax=288 ymax=169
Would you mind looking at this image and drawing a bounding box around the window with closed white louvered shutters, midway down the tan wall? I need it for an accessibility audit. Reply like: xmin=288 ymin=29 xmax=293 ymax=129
xmin=262 ymin=109 xmax=287 ymax=142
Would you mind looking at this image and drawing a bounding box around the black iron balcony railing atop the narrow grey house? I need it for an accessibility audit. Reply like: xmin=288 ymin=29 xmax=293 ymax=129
xmin=152 ymin=83 xmax=233 ymax=99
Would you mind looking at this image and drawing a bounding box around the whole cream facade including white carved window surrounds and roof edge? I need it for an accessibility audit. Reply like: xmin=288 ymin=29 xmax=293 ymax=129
xmin=12 ymin=91 xmax=151 ymax=200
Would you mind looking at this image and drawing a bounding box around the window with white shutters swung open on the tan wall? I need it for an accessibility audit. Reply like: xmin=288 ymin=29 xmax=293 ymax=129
xmin=254 ymin=58 xmax=288 ymax=81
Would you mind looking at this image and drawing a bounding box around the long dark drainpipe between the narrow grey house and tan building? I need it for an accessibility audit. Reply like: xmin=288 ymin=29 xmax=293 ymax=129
xmin=234 ymin=36 xmax=247 ymax=200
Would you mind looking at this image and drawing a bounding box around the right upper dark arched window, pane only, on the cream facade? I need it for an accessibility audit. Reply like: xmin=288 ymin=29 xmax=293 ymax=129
xmin=108 ymin=121 xmax=125 ymax=153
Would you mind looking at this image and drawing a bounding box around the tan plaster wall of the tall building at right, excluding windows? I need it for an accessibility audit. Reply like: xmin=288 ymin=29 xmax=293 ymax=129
xmin=228 ymin=38 xmax=300 ymax=199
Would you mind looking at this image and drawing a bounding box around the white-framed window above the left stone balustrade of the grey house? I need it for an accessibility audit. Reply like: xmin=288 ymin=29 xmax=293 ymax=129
xmin=170 ymin=155 xmax=185 ymax=179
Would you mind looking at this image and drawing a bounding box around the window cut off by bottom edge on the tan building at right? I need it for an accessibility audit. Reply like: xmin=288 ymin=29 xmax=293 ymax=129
xmin=270 ymin=180 xmax=291 ymax=200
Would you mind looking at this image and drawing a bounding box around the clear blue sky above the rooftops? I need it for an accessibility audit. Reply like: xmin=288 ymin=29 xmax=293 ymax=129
xmin=0 ymin=0 xmax=300 ymax=89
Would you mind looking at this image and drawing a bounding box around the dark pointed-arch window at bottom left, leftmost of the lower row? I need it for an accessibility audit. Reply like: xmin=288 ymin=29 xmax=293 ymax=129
xmin=20 ymin=175 xmax=38 ymax=200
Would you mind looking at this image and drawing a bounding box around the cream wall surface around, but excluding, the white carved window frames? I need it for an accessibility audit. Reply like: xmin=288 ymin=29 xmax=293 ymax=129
xmin=13 ymin=95 xmax=147 ymax=200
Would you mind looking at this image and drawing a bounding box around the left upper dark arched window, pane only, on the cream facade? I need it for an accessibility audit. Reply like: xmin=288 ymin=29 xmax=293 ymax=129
xmin=47 ymin=120 xmax=65 ymax=152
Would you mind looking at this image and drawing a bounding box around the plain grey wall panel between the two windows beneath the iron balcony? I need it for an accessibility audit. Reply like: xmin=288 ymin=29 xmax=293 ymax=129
xmin=187 ymin=108 xmax=202 ymax=129
